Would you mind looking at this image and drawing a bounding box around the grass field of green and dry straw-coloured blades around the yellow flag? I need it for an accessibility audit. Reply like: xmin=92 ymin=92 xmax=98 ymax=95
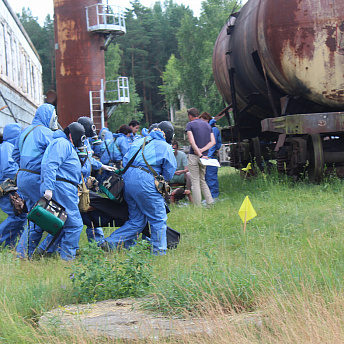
xmin=0 ymin=167 xmax=344 ymax=343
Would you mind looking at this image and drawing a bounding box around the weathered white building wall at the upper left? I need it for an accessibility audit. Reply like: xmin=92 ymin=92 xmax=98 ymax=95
xmin=0 ymin=0 xmax=43 ymax=136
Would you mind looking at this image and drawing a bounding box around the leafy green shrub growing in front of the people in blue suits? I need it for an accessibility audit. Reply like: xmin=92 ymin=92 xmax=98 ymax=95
xmin=70 ymin=241 xmax=152 ymax=302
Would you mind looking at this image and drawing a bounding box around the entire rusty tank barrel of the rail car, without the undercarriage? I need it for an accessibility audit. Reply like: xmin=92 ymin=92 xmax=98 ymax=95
xmin=213 ymin=0 xmax=344 ymax=127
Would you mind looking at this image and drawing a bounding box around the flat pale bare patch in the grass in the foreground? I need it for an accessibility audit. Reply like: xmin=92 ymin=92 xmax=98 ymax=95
xmin=39 ymin=299 xmax=262 ymax=340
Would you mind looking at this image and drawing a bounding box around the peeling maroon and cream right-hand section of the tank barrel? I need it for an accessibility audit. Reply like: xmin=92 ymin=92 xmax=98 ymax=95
xmin=257 ymin=0 xmax=344 ymax=109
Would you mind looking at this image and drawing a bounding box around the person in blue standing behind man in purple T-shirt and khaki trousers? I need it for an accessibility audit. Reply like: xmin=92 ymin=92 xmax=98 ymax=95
xmin=200 ymin=112 xmax=222 ymax=198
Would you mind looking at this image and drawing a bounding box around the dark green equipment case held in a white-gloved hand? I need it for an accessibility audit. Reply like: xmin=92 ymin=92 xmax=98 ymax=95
xmin=27 ymin=197 xmax=67 ymax=236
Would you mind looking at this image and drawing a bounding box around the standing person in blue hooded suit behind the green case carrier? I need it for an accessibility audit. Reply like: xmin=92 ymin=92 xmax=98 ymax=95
xmin=12 ymin=104 xmax=58 ymax=258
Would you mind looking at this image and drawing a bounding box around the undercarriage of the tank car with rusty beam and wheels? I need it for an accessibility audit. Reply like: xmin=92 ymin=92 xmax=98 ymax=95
xmin=223 ymin=112 xmax=344 ymax=183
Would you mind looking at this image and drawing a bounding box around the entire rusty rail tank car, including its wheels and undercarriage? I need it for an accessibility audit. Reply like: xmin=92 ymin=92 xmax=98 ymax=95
xmin=213 ymin=0 xmax=344 ymax=182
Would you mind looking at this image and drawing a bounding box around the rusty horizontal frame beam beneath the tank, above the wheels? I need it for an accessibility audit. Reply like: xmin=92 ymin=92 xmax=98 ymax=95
xmin=261 ymin=112 xmax=344 ymax=135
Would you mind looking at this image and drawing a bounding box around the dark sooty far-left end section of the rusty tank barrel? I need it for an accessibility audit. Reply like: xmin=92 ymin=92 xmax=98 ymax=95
xmin=213 ymin=0 xmax=279 ymax=119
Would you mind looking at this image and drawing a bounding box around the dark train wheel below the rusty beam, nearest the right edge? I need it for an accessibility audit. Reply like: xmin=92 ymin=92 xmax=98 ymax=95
xmin=307 ymin=134 xmax=324 ymax=183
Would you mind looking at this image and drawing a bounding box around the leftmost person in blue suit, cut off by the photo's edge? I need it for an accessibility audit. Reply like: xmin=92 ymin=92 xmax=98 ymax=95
xmin=0 ymin=123 xmax=26 ymax=248
